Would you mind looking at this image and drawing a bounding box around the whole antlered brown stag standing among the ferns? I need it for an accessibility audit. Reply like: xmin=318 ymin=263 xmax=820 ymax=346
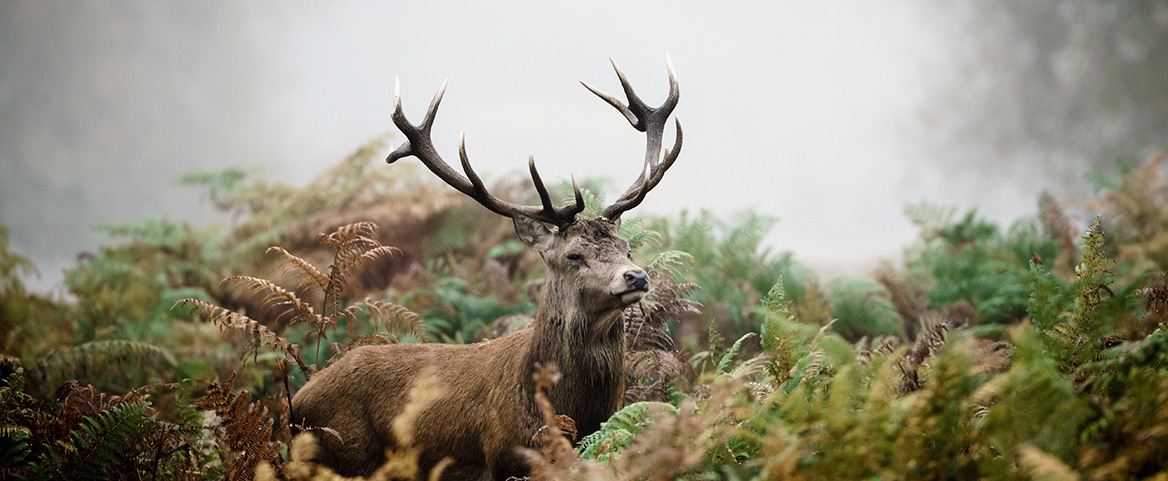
xmin=292 ymin=55 xmax=682 ymax=481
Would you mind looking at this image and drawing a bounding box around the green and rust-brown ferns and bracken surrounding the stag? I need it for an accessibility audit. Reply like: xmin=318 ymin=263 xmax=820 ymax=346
xmin=0 ymin=141 xmax=1168 ymax=480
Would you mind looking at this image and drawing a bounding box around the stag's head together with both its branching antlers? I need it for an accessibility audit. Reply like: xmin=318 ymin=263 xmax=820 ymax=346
xmin=385 ymin=55 xmax=682 ymax=322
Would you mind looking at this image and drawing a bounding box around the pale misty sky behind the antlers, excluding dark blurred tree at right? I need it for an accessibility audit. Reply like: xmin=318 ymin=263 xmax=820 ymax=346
xmin=0 ymin=0 xmax=1111 ymax=287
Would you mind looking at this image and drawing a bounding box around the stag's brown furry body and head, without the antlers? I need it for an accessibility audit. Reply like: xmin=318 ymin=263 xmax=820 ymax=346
xmin=292 ymin=216 xmax=647 ymax=481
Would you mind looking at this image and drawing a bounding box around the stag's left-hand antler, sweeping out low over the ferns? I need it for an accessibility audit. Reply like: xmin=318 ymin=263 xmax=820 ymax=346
xmin=385 ymin=78 xmax=584 ymax=228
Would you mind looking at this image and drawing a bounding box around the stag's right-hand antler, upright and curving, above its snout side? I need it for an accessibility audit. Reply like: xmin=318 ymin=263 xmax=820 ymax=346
xmin=580 ymin=53 xmax=682 ymax=219
